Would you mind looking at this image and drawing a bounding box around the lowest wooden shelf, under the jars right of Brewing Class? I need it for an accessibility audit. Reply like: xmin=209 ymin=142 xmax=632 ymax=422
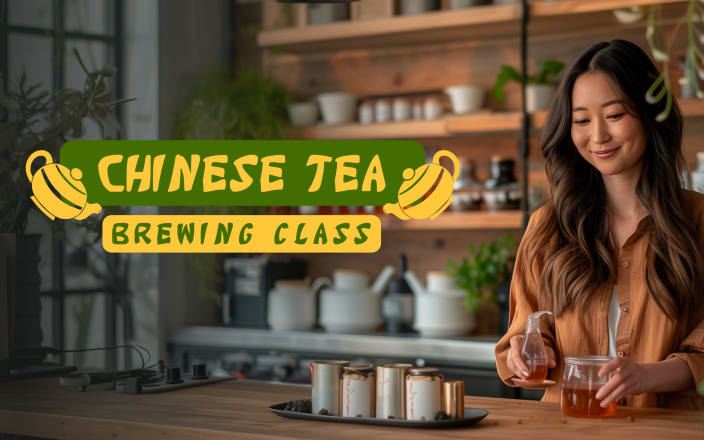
xmin=381 ymin=211 xmax=523 ymax=231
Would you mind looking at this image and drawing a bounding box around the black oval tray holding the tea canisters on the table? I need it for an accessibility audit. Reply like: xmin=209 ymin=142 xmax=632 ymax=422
xmin=268 ymin=402 xmax=489 ymax=429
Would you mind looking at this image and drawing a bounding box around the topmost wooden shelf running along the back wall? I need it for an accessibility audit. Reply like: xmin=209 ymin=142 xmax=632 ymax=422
xmin=257 ymin=0 xmax=686 ymax=53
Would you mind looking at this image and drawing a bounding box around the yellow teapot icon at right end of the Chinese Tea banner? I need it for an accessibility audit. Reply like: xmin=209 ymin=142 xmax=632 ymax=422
xmin=384 ymin=150 xmax=460 ymax=220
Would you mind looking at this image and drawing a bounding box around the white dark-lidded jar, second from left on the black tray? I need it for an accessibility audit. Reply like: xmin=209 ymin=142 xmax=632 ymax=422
xmin=341 ymin=365 xmax=376 ymax=417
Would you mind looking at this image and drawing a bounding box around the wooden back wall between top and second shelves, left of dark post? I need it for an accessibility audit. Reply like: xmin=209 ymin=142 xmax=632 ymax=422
xmin=266 ymin=42 xmax=520 ymax=110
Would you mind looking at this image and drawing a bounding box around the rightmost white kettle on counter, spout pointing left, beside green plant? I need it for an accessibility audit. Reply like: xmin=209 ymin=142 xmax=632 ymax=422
xmin=403 ymin=270 xmax=475 ymax=337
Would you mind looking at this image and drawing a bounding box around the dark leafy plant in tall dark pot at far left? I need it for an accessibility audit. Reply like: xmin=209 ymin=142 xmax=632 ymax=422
xmin=0 ymin=50 xmax=132 ymax=367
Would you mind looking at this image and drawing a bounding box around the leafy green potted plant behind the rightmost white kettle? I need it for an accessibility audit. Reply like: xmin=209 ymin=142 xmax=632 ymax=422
xmin=447 ymin=234 xmax=516 ymax=334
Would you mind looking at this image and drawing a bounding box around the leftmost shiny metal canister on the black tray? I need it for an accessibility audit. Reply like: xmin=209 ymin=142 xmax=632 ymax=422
xmin=309 ymin=361 xmax=349 ymax=416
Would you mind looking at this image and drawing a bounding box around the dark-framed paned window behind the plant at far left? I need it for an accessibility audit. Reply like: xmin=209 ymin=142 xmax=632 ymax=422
xmin=0 ymin=0 xmax=124 ymax=367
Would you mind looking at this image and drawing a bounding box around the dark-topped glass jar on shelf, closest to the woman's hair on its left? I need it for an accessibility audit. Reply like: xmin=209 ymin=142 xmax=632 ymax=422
xmin=483 ymin=156 xmax=523 ymax=211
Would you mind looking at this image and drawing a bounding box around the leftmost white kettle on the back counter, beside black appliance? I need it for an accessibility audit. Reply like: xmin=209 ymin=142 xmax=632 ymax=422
xmin=267 ymin=277 xmax=332 ymax=330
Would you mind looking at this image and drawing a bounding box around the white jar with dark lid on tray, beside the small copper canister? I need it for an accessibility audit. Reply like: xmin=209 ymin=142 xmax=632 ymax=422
xmin=406 ymin=368 xmax=443 ymax=420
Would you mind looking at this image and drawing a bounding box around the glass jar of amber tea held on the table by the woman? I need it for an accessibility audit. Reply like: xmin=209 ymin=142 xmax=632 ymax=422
xmin=560 ymin=356 xmax=616 ymax=417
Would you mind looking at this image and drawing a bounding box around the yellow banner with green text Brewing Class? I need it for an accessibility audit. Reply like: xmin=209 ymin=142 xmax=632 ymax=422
xmin=103 ymin=215 xmax=381 ymax=253
